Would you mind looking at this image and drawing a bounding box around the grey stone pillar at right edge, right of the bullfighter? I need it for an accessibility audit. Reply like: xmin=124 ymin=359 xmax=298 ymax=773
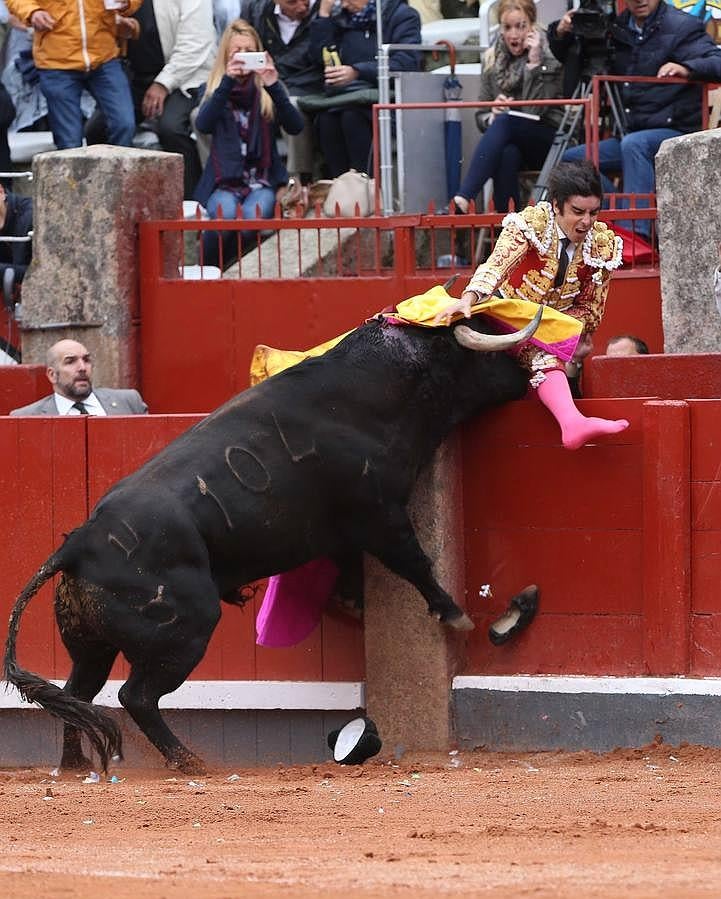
xmin=656 ymin=128 xmax=721 ymax=353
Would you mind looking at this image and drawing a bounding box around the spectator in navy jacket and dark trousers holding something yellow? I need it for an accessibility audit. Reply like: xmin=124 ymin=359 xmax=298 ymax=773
xmin=310 ymin=0 xmax=421 ymax=178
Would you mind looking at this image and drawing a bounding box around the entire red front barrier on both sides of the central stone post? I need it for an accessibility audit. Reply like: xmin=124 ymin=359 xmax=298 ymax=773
xmin=0 ymin=386 xmax=721 ymax=681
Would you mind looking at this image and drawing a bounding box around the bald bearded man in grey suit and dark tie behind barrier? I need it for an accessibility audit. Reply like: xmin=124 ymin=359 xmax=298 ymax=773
xmin=10 ymin=340 xmax=148 ymax=415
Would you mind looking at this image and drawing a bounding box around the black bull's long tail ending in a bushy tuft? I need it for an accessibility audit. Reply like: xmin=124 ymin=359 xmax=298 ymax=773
xmin=4 ymin=550 xmax=122 ymax=771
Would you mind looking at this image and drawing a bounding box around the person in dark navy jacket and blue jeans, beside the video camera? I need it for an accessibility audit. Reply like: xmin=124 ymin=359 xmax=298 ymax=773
xmin=548 ymin=0 xmax=721 ymax=237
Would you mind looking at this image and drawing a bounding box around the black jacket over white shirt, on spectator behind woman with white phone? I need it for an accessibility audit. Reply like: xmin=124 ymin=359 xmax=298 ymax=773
xmin=241 ymin=0 xmax=323 ymax=97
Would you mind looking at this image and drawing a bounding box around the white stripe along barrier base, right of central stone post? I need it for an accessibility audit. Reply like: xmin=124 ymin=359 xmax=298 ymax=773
xmin=453 ymin=674 xmax=721 ymax=696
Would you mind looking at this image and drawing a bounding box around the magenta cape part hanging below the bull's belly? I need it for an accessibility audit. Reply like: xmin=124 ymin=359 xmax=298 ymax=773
xmin=255 ymin=558 xmax=338 ymax=647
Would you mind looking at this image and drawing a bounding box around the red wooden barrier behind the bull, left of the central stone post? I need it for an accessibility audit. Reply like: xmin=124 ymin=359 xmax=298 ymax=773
xmin=0 ymin=415 xmax=363 ymax=681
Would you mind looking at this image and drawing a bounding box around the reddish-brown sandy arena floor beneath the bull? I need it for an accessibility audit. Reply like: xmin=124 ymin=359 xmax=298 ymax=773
xmin=0 ymin=746 xmax=721 ymax=899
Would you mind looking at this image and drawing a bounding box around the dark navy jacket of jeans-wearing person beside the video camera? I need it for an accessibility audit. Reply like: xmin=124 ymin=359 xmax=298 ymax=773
xmin=548 ymin=0 xmax=721 ymax=132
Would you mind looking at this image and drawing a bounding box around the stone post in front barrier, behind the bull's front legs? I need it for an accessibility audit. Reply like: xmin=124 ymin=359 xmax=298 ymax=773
xmin=365 ymin=434 xmax=466 ymax=755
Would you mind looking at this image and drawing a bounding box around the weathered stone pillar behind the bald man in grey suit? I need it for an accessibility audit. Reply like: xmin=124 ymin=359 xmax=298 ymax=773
xmin=22 ymin=145 xmax=183 ymax=387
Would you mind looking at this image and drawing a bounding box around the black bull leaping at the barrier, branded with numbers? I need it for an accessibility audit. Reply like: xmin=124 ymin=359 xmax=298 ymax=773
xmin=5 ymin=319 xmax=536 ymax=773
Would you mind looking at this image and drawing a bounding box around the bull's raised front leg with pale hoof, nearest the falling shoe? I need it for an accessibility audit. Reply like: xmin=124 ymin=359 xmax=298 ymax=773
xmin=367 ymin=510 xmax=473 ymax=630
